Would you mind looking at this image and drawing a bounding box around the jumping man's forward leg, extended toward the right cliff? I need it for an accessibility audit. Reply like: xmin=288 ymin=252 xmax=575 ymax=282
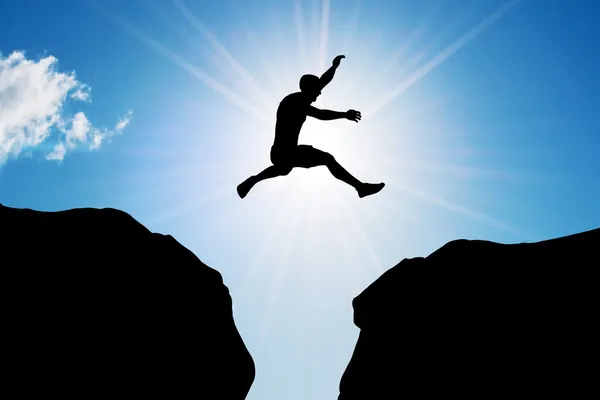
xmin=295 ymin=145 xmax=385 ymax=198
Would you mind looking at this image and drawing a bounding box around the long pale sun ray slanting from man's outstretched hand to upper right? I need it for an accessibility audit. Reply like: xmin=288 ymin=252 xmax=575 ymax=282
xmin=364 ymin=0 xmax=523 ymax=117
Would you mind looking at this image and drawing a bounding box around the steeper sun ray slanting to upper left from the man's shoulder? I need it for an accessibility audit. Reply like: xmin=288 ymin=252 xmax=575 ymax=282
xmin=172 ymin=0 xmax=274 ymax=108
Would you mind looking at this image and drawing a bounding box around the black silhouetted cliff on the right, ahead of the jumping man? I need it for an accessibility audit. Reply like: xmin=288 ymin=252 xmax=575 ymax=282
xmin=339 ymin=229 xmax=600 ymax=400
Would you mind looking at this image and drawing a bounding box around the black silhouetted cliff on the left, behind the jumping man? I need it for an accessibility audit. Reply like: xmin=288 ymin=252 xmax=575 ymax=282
xmin=0 ymin=205 xmax=255 ymax=400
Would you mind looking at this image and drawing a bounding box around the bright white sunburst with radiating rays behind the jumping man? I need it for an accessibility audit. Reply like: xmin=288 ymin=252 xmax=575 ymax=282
xmin=88 ymin=0 xmax=529 ymax=396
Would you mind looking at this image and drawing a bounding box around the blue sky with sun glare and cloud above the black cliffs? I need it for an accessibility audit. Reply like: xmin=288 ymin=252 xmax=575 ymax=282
xmin=0 ymin=0 xmax=600 ymax=400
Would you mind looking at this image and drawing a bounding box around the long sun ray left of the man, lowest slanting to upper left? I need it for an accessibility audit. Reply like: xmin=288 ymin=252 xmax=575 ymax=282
xmin=91 ymin=1 xmax=271 ymax=125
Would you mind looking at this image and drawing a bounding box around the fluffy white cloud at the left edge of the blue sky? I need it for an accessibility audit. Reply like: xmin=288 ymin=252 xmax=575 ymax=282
xmin=0 ymin=52 xmax=133 ymax=166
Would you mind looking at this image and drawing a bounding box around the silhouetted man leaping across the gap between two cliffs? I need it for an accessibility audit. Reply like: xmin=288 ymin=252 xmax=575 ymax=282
xmin=237 ymin=56 xmax=385 ymax=199
